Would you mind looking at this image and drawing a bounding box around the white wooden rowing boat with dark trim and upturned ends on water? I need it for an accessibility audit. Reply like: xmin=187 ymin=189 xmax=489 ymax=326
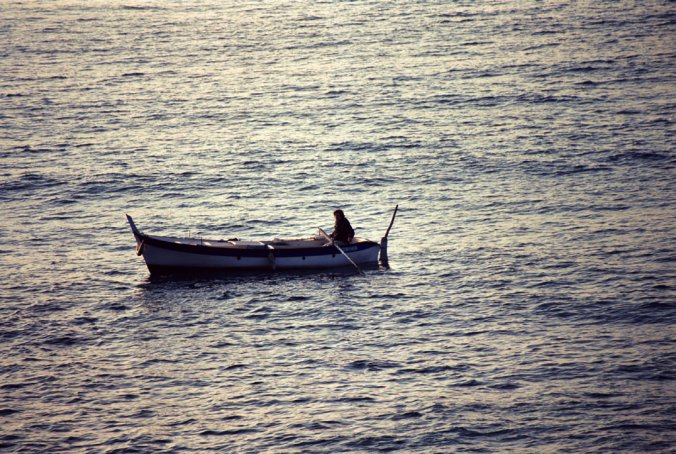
xmin=126 ymin=207 xmax=398 ymax=275
